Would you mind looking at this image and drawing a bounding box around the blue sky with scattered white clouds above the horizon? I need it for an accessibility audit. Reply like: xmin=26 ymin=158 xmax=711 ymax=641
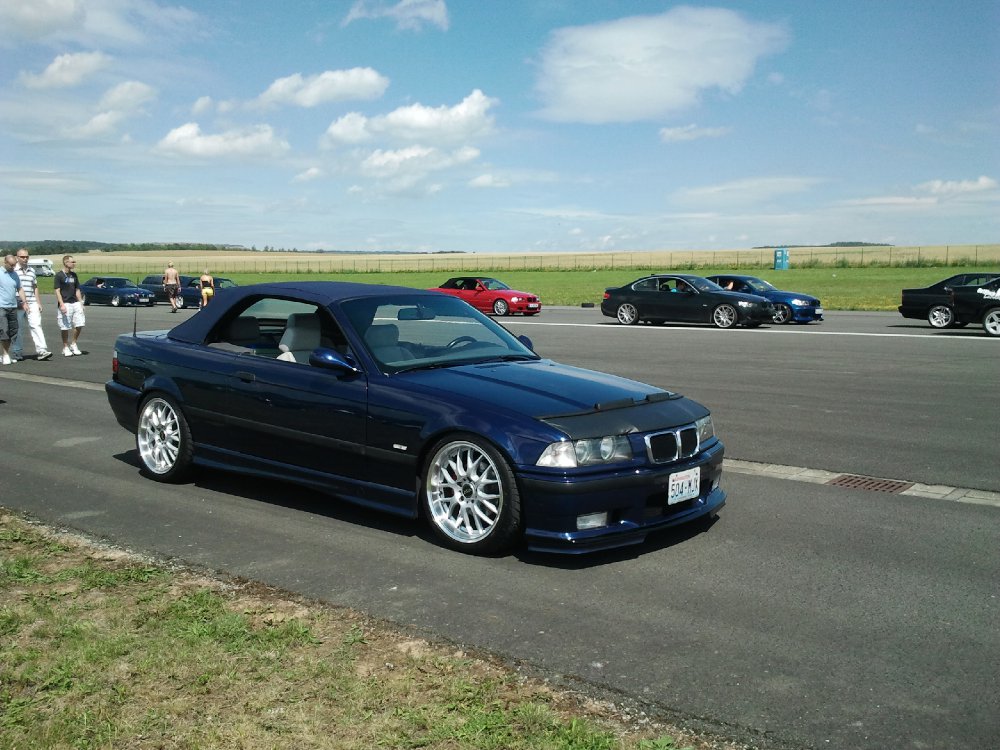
xmin=0 ymin=0 xmax=1000 ymax=253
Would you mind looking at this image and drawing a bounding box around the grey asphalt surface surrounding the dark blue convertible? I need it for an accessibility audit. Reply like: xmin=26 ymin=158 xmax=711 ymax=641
xmin=0 ymin=306 xmax=1000 ymax=749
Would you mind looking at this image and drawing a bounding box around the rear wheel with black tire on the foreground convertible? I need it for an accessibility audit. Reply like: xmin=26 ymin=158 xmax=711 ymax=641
xmin=135 ymin=394 xmax=194 ymax=482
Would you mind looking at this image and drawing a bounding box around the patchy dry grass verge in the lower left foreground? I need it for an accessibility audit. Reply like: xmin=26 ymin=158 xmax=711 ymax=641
xmin=0 ymin=509 xmax=737 ymax=750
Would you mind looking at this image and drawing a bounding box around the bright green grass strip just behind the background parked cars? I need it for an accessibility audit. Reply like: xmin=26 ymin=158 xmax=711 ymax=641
xmin=197 ymin=266 xmax=993 ymax=311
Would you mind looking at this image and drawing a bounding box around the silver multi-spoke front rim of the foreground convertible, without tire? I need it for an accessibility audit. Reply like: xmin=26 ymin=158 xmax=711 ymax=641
xmin=425 ymin=440 xmax=506 ymax=544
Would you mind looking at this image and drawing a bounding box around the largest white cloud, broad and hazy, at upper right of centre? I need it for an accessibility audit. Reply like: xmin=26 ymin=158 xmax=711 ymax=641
xmin=536 ymin=6 xmax=787 ymax=123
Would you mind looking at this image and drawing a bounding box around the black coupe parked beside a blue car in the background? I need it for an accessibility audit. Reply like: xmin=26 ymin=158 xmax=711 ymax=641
xmin=601 ymin=274 xmax=774 ymax=328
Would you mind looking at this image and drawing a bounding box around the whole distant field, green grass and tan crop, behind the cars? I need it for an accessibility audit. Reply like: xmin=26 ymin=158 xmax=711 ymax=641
xmin=53 ymin=245 xmax=1000 ymax=310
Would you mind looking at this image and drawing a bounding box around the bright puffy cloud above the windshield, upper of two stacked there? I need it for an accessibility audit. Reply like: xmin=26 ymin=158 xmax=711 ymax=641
xmin=323 ymin=89 xmax=497 ymax=146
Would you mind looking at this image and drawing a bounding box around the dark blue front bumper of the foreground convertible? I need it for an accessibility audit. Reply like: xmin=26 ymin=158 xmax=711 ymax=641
xmin=521 ymin=442 xmax=726 ymax=554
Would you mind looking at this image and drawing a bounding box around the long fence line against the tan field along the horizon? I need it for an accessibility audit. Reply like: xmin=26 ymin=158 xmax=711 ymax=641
xmin=68 ymin=244 xmax=1000 ymax=275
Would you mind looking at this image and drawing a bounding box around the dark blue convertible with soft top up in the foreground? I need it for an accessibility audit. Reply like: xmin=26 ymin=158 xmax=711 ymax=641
xmin=105 ymin=281 xmax=726 ymax=553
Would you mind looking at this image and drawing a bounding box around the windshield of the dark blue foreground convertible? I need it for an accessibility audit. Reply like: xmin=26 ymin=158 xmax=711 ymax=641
xmin=343 ymin=295 xmax=539 ymax=373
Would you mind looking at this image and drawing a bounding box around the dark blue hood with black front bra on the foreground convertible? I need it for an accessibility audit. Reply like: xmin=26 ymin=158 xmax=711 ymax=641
xmin=402 ymin=360 xmax=708 ymax=438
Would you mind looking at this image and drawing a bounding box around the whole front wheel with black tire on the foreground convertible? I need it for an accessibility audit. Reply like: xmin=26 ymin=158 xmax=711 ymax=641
xmin=421 ymin=435 xmax=521 ymax=555
